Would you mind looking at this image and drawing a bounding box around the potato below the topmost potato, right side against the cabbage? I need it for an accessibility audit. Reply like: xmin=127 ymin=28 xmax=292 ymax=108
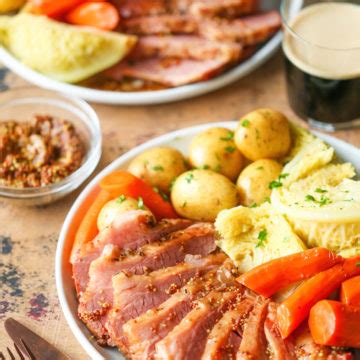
xmin=236 ymin=159 xmax=282 ymax=206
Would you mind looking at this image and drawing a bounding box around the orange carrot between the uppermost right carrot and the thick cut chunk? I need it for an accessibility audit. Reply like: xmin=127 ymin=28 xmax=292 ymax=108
xmin=277 ymin=256 xmax=360 ymax=338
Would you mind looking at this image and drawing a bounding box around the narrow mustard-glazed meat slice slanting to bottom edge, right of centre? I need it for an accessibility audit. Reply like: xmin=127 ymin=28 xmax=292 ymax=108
xmin=201 ymin=297 xmax=254 ymax=360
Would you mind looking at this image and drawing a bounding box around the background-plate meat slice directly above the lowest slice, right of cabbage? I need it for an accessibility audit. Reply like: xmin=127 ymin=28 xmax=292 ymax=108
xmin=130 ymin=35 xmax=242 ymax=63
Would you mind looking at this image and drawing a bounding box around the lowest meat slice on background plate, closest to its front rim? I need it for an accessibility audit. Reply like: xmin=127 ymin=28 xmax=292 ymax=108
xmin=105 ymin=58 xmax=228 ymax=87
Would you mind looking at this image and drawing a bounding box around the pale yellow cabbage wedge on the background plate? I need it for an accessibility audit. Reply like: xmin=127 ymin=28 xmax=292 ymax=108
xmin=0 ymin=13 xmax=136 ymax=83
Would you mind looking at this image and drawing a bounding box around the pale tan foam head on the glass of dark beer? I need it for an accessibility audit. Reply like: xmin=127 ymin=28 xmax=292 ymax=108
xmin=283 ymin=2 xmax=360 ymax=79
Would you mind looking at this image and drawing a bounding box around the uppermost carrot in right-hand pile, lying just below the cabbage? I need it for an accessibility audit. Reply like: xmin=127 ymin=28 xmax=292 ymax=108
xmin=237 ymin=248 xmax=343 ymax=297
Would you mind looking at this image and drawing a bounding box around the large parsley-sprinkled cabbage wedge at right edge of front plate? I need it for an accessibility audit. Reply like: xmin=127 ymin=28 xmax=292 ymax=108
xmin=271 ymin=135 xmax=360 ymax=254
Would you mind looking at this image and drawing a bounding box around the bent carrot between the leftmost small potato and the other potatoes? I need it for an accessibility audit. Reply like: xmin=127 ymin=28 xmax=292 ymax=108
xmin=99 ymin=170 xmax=179 ymax=220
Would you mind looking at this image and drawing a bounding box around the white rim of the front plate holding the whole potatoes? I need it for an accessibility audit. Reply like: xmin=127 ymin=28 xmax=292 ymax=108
xmin=55 ymin=121 xmax=360 ymax=360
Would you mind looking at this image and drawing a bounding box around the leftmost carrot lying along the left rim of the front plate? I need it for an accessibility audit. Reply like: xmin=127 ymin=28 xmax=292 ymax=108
xmin=71 ymin=190 xmax=112 ymax=258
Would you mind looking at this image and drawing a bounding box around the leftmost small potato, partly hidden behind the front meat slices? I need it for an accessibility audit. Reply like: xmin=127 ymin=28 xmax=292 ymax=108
xmin=97 ymin=195 xmax=150 ymax=231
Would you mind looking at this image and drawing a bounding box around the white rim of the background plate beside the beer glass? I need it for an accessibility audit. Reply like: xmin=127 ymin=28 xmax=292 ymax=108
xmin=0 ymin=0 xmax=282 ymax=105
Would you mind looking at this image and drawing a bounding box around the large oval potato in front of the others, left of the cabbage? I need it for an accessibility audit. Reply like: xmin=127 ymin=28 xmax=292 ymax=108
xmin=171 ymin=170 xmax=238 ymax=221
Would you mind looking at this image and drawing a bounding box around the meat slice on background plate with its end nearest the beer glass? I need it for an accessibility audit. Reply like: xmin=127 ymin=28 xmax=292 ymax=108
xmin=199 ymin=11 xmax=281 ymax=46
